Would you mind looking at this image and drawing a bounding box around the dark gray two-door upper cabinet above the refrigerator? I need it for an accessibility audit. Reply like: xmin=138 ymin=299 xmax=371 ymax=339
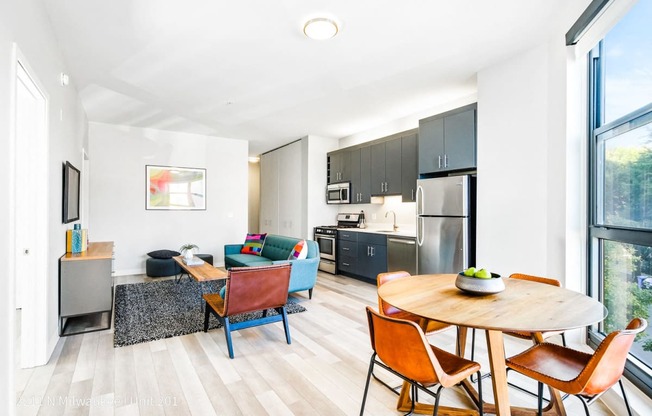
xmin=418 ymin=104 xmax=477 ymax=174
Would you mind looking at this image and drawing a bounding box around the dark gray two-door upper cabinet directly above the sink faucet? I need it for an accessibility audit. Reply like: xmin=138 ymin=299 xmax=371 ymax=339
xmin=371 ymin=138 xmax=401 ymax=195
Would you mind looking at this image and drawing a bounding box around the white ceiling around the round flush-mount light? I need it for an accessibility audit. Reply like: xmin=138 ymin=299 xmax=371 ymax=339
xmin=43 ymin=0 xmax=589 ymax=155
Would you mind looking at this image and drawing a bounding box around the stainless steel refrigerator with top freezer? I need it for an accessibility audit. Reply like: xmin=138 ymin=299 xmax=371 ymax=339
xmin=417 ymin=175 xmax=475 ymax=274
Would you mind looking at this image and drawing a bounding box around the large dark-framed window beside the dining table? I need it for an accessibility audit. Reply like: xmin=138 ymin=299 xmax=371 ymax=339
xmin=589 ymin=0 xmax=652 ymax=394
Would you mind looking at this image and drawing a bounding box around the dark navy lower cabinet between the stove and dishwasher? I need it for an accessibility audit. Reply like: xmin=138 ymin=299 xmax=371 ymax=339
xmin=337 ymin=231 xmax=387 ymax=282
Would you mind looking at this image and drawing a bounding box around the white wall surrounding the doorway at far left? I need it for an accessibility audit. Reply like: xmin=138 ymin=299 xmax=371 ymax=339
xmin=0 ymin=0 xmax=86 ymax=404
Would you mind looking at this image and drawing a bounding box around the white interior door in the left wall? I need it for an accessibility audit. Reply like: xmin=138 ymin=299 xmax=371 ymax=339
xmin=13 ymin=60 xmax=49 ymax=367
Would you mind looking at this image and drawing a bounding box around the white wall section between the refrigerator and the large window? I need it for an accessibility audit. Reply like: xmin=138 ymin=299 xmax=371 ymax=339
xmin=477 ymin=37 xmax=583 ymax=281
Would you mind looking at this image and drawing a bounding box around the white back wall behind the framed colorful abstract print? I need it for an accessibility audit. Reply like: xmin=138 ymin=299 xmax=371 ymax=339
xmin=88 ymin=123 xmax=248 ymax=275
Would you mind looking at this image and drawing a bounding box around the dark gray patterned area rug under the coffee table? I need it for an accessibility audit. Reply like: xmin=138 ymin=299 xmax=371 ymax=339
xmin=113 ymin=279 xmax=306 ymax=347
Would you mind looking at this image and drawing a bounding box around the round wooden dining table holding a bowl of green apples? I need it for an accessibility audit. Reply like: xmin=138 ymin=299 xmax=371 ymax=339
xmin=378 ymin=274 xmax=607 ymax=415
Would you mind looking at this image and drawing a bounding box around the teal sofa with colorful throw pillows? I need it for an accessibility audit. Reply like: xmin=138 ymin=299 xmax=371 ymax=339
xmin=224 ymin=234 xmax=319 ymax=299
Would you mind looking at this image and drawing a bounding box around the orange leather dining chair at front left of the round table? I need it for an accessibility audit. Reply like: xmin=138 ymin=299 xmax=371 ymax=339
xmin=360 ymin=306 xmax=483 ymax=416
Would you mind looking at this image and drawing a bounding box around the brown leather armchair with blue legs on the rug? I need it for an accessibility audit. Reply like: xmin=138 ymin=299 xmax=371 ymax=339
xmin=203 ymin=263 xmax=292 ymax=358
